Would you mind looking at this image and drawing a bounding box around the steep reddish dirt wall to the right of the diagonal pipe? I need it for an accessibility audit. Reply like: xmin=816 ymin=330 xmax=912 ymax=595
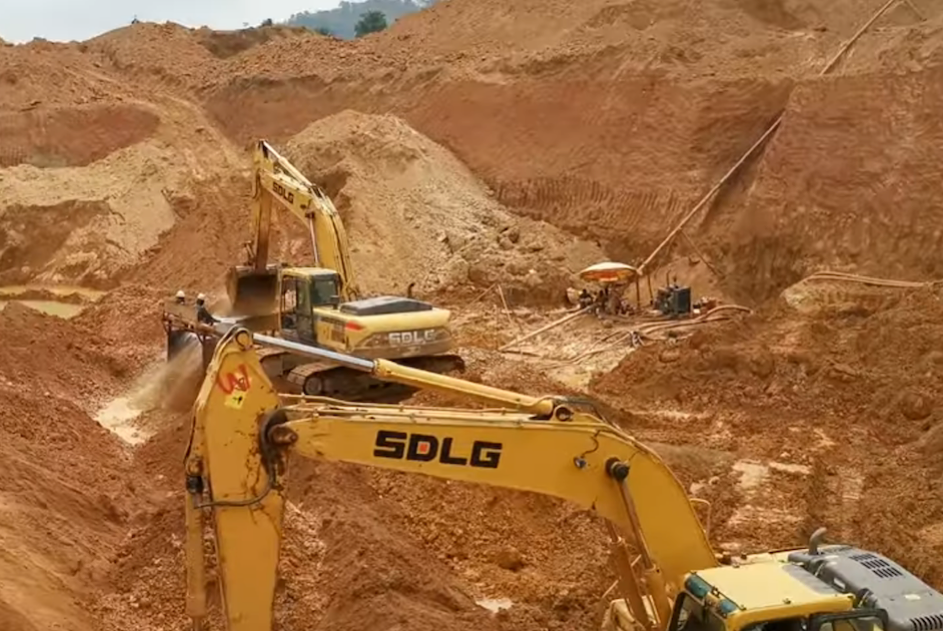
xmin=710 ymin=69 xmax=943 ymax=299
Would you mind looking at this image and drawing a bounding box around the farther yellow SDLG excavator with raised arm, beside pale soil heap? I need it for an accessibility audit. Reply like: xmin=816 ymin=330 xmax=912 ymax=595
xmin=163 ymin=140 xmax=465 ymax=400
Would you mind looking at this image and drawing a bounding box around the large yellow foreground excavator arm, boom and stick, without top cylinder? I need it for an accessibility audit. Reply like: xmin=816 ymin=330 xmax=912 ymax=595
xmin=186 ymin=329 xmax=718 ymax=631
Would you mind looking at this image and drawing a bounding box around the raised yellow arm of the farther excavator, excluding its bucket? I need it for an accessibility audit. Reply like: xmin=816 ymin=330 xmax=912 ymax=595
xmin=250 ymin=140 xmax=360 ymax=302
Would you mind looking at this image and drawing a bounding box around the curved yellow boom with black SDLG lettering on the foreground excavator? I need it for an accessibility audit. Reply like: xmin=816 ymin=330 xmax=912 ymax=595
xmin=288 ymin=408 xmax=717 ymax=588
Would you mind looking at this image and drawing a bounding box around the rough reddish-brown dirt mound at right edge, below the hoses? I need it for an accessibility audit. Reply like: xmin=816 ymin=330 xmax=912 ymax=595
xmin=592 ymin=290 xmax=943 ymax=444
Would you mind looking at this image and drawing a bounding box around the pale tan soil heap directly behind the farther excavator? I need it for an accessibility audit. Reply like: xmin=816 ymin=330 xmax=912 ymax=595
xmin=286 ymin=111 xmax=602 ymax=300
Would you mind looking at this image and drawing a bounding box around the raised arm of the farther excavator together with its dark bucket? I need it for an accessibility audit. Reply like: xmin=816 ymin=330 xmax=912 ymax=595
xmin=228 ymin=140 xmax=360 ymax=310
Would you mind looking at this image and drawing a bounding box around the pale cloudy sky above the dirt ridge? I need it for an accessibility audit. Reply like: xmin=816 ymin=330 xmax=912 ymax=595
xmin=0 ymin=0 xmax=339 ymax=44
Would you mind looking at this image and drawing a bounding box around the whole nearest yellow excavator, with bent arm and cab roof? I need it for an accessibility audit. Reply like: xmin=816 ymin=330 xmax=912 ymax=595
xmin=185 ymin=327 xmax=943 ymax=631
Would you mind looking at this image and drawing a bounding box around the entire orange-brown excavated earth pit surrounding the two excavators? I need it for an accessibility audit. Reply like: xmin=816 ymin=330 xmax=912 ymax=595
xmin=0 ymin=0 xmax=943 ymax=631
